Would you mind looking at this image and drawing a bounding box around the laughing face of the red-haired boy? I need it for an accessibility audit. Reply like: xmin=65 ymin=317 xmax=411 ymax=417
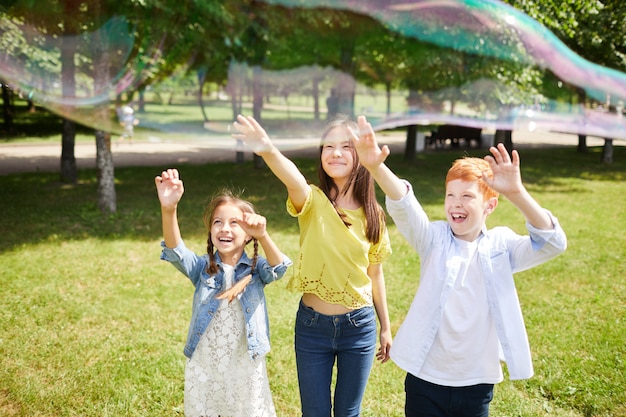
xmin=444 ymin=180 xmax=498 ymax=242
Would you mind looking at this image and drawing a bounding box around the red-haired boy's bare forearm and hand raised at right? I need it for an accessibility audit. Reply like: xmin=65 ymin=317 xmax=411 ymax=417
xmin=482 ymin=143 xmax=554 ymax=230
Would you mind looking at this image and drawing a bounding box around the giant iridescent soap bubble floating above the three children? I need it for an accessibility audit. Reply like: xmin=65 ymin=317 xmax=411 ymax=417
xmin=0 ymin=0 xmax=626 ymax=147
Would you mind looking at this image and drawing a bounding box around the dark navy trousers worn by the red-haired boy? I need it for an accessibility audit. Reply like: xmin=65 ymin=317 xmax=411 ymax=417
xmin=404 ymin=374 xmax=493 ymax=417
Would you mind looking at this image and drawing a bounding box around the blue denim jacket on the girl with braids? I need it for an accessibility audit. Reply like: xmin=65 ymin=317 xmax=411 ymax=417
xmin=161 ymin=241 xmax=291 ymax=359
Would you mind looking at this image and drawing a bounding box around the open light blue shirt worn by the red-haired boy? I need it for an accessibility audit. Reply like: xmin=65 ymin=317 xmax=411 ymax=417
xmin=386 ymin=181 xmax=567 ymax=379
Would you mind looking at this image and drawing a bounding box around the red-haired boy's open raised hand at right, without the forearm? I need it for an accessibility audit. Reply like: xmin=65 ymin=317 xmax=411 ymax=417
xmin=482 ymin=143 xmax=524 ymax=196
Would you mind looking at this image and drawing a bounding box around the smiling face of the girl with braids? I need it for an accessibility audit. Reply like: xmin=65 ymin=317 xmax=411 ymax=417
xmin=209 ymin=203 xmax=251 ymax=265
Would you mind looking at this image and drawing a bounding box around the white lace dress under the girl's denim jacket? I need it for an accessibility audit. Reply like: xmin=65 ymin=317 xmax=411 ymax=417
xmin=185 ymin=265 xmax=276 ymax=417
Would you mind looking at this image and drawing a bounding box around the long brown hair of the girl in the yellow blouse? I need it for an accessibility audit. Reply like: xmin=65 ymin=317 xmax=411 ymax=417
xmin=317 ymin=114 xmax=385 ymax=243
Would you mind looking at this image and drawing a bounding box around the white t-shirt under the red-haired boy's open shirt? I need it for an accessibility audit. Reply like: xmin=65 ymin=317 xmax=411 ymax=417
xmin=418 ymin=238 xmax=503 ymax=387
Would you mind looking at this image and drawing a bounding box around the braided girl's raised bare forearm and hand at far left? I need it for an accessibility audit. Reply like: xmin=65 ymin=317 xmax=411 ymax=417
xmin=154 ymin=169 xmax=185 ymax=249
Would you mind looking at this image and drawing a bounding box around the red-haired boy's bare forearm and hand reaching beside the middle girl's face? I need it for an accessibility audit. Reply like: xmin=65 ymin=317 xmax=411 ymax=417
xmin=350 ymin=116 xmax=408 ymax=200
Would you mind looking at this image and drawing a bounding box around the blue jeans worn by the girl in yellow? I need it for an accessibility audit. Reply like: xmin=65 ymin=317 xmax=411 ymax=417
xmin=295 ymin=301 xmax=377 ymax=417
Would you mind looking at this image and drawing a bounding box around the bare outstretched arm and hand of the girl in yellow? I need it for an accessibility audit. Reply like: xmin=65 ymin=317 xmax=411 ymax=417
xmin=232 ymin=115 xmax=311 ymax=210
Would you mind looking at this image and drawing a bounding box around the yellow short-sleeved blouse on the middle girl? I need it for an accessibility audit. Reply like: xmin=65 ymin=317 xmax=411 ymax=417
xmin=287 ymin=185 xmax=391 ymax=309
